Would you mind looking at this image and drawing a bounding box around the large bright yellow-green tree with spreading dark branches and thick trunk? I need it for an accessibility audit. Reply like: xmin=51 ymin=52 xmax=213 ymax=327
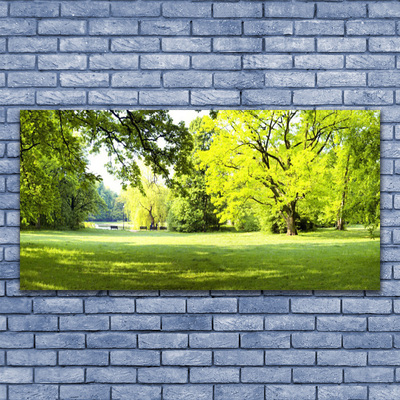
xmin=199 ymin=110 xmax=374 ymax=235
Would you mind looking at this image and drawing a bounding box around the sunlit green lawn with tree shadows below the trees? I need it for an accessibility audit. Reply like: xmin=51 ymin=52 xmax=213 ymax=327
xmin=21 ymin=227 xmax=380 ymax=290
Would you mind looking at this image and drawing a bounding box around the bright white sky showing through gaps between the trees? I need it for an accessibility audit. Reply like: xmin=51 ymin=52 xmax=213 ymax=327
xmin=89 ymin=110 xmax=209 ymax=194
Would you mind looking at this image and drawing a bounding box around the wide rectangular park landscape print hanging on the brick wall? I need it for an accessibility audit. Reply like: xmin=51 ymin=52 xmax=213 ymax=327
xmin=20 ymin=109 xmax=380 ymax=291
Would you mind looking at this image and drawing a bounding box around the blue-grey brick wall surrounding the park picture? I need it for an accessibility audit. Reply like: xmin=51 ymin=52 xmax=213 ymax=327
xmin=0 ymin=0 xmax=400 ymax=400
